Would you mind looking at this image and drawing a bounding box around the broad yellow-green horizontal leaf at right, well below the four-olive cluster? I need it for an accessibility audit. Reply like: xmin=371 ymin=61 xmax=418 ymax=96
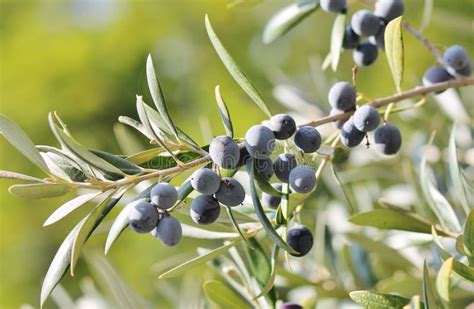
xmin=349 ymin=209 xmax=440 ymax=234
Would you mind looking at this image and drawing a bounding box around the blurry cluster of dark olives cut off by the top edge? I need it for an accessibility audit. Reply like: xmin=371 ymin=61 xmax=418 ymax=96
xmin=320 ymin=0 xmax=404 ymax=67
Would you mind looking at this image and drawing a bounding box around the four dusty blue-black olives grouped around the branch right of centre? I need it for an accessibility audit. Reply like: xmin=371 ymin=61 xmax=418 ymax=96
xmin=328 ymin=82 xmax=402 ymax=155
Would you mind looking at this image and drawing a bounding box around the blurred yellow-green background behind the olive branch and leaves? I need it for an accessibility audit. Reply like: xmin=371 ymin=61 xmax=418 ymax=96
xmin=0 ymin=0 xmax=474 ymax=308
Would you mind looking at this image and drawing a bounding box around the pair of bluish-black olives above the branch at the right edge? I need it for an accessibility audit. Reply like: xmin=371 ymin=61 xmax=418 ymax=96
xmin=423 ymin=45 xmax=472 ymax=92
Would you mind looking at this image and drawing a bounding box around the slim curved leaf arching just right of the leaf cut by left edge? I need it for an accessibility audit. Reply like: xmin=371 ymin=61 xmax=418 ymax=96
xmin=48 ymin=113 xmax=123 ymax=175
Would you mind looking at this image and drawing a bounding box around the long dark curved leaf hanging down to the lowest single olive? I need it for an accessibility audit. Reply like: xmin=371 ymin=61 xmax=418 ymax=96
xmin=247 ymin=159 xmax=298 ymax=254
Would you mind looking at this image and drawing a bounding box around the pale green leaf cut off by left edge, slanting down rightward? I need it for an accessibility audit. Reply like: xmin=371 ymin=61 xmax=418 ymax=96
xmin=0 ymin=115 xmax=49 ymax=173
